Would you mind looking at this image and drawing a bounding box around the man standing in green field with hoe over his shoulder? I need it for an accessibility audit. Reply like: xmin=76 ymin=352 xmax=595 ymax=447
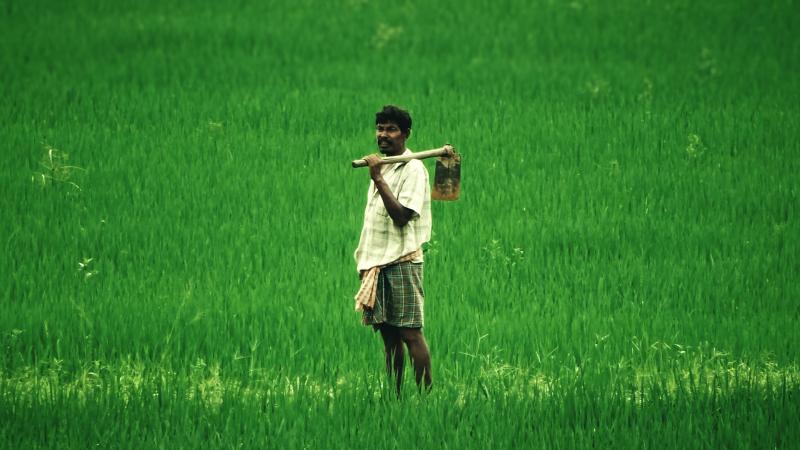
xmin=355 ymin=105 xmax=431 ymax=395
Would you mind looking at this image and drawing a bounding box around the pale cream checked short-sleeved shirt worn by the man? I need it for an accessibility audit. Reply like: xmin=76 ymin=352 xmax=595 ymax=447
xmin=354 ymin=149 xmax=431 ymax=271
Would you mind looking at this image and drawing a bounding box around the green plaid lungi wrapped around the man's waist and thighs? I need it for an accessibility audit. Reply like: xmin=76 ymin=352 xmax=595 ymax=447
xmin=362 ymin=262 xmax=425 ymax=328
